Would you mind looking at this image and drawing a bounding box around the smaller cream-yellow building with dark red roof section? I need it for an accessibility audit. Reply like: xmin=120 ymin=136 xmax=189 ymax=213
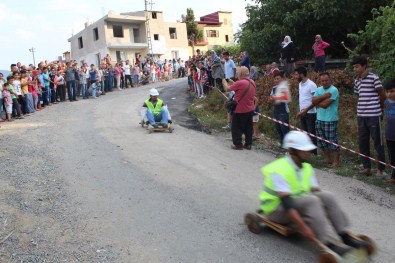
xmin=195 ymin=11 xmax=234 ymax=52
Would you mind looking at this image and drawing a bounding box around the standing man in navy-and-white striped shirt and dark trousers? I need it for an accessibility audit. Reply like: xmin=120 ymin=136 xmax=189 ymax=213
xmin=352 ymin=56 xmax=386 ymax=177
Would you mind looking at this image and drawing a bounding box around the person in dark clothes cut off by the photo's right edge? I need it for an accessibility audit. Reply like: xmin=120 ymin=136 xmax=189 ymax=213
xmin=384 ymin=79 xmax=395 ymax=184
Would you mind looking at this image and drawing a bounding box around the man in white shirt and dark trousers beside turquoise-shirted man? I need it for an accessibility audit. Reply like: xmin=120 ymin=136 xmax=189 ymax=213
xmin=295 ymin=67 xmax=317 ymax=155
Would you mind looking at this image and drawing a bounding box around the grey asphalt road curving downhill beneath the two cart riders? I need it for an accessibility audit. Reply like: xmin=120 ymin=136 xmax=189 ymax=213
xmin=0 ymin=79 xmax=395 ymax=263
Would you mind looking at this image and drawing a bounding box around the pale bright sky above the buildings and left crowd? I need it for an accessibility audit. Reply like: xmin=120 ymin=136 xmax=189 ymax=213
xmin=0 ymin=0 xmax=254 ymax=70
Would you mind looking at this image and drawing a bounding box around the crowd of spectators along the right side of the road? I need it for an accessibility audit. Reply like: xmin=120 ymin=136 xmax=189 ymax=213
xmin=187 ymin=44 xmax=395 ymax=183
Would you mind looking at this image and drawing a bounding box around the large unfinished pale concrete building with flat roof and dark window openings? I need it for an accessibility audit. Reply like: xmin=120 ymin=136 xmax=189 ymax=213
xmin=68 ymin=11 xmax=189 ymax=66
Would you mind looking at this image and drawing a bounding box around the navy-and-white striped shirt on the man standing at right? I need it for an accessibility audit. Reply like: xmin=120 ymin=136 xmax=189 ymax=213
xmin=354 ymin=72 xmax=383 ymax=117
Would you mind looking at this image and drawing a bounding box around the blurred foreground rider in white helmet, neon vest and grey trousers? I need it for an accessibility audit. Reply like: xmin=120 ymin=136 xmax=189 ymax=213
xmin=259 ymin=131 xmax=369 ymax=256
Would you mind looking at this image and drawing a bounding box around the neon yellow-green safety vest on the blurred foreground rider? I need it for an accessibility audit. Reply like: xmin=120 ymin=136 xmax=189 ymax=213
xmin=259 ymin=157 xmax=313 ymax=215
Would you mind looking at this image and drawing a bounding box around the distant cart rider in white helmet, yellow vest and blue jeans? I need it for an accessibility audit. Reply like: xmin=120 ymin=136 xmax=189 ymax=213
xmin=141 ymin=89 xmax=171 ymax=128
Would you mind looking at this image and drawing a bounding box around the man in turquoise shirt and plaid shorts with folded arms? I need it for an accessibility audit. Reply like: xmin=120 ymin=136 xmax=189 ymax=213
xmin=309 ymin=72 xmax=340 ymax=168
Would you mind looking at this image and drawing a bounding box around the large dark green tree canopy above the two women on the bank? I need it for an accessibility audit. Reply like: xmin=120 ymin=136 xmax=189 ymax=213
xmin=237 ymin=0 xmax=392 ymax=63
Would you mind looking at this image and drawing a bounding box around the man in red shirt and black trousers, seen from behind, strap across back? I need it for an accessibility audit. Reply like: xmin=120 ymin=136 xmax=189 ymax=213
xmin=223 ymin=66 xmax=255 ymax=150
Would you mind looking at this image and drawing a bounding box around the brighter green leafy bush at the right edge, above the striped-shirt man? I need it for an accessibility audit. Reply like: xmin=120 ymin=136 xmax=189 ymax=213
xmin=349 ymin=3 xmax=395 ymax=80
